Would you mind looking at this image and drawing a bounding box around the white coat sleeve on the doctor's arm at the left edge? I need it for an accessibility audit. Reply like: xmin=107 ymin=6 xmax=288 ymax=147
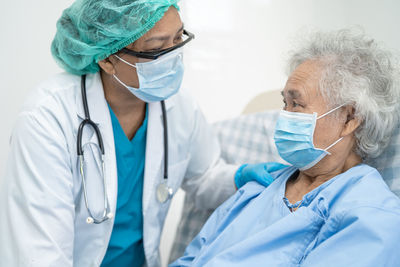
xmin=0 ymin=112 xmax=74 ymax=266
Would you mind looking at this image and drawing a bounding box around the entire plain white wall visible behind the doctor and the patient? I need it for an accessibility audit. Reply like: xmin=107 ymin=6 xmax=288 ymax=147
xmin=0 ymin=0 xmax=400 ymax=267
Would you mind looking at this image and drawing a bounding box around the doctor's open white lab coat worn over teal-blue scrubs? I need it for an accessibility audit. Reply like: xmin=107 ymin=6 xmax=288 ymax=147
xmin=0 ymin=73 xmax=237 ymax=267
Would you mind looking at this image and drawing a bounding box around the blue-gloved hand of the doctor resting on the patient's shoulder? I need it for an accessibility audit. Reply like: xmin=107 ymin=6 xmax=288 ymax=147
xmin=235 ymin=162 xmax=288 ymax=188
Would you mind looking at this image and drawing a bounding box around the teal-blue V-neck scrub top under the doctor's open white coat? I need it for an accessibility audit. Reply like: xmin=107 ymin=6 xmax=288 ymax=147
xmin=101 ymin=106 xmax=148 ymax=267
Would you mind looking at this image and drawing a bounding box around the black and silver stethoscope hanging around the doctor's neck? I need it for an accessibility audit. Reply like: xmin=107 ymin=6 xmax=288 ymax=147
xmin=77 ymin=75 xmax=173 ymax=224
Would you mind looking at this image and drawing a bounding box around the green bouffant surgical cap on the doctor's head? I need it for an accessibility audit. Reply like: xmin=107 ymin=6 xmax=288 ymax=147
xmin=51 ymin=0 xmax=179 ymax=75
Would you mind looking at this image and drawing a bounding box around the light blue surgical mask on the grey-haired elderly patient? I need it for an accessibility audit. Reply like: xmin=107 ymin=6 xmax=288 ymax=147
xmin=274 ymin=105 xmax=344 ymax=171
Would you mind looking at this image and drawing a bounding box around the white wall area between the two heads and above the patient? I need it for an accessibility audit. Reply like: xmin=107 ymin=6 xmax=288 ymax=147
xmin=181 ymin=0 xmax=400 ymax=121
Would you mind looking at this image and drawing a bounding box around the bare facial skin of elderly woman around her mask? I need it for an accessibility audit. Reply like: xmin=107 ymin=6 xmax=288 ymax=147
xmin=282 ymin=61 xmax=343 ymax=153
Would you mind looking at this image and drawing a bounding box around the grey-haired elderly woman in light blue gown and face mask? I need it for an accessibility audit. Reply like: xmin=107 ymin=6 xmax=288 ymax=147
xmin=171 ymin=30 xmax=400 ymax=266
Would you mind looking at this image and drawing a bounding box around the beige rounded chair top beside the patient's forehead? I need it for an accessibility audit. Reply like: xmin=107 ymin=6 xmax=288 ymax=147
xmin=242 ymin=90 xmax=283 ymax=114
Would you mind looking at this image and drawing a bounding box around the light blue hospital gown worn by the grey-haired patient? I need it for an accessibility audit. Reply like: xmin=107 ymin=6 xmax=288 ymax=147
xmin=170 ymin=164 xmax=400 ymax=267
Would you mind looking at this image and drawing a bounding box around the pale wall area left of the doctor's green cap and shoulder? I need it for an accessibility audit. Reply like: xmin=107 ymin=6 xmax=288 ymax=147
xmin=0 ymin=0 xmax=73 ymax=175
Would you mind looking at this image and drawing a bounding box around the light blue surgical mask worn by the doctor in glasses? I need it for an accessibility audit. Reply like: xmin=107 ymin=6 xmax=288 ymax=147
xmin=114 ymin=48 xmax=183 ymax=103
